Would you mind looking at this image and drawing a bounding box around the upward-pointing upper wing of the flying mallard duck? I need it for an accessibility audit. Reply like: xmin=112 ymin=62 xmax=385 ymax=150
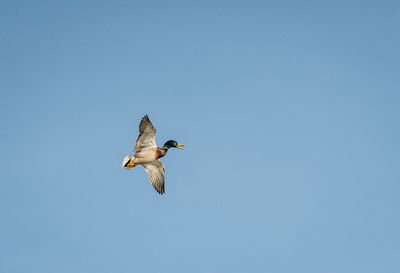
xmin=135 ymin=115 xmax=157 ymax=153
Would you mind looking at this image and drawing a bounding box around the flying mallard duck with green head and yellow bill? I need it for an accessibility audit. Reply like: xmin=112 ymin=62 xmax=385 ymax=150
xmin=122 ymin=115 xmax=185 ymax=194
